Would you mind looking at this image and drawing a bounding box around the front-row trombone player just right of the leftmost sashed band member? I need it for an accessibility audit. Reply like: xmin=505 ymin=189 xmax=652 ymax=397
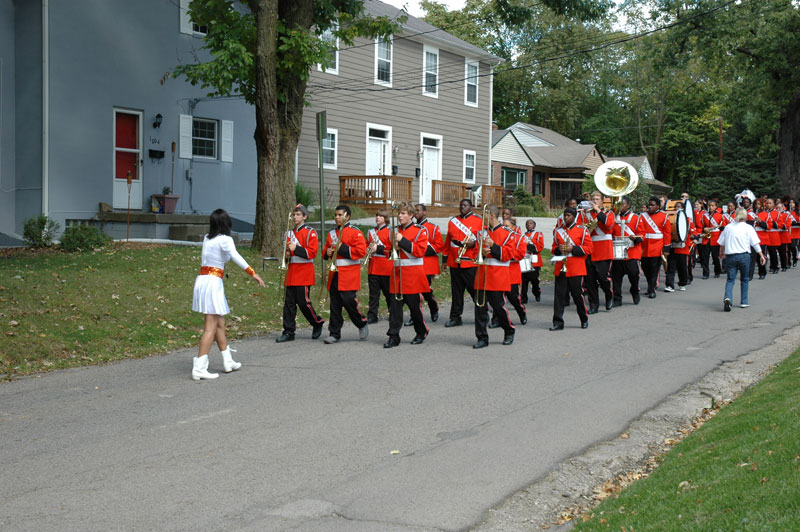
xmin=472 ymin=205 xmax=514 ymax=349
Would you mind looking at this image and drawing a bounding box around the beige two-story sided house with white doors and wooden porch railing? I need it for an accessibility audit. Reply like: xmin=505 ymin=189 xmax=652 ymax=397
xmin=296 ymin=0 xmax=500 ymax=212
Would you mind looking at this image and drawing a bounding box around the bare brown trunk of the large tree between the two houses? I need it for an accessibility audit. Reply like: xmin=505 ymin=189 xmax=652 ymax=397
xmin=249 ymin=0 xmax=313 ymax=257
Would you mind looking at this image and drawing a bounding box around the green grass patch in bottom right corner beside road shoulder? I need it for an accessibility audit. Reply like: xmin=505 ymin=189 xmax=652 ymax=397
xmin=575 ymin=350 xmax=800 ymax=532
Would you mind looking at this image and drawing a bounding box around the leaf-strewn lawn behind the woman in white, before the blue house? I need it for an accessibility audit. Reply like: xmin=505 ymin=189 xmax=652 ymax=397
xmin=0 ymin=243 xmax=552 ymax=379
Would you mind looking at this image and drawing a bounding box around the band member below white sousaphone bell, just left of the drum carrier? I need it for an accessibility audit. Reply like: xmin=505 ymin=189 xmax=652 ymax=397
xmin=584 ymin=190 xmax=616 ymax=314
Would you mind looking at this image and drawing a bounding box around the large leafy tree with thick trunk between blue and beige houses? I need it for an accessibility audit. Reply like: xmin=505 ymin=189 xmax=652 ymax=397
xmin=173 ymin=0 xmax=404 ymax=256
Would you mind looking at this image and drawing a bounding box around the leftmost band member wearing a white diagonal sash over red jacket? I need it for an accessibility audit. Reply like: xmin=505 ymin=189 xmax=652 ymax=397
xmin=442 ymin=199 xmax=483 ymax=327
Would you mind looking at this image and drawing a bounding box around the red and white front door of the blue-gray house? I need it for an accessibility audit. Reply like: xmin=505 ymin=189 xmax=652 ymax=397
xmin=111 ymin=109 xmax=142 ymax=210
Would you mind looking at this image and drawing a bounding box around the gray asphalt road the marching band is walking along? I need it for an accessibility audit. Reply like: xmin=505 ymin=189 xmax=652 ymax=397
xmin=0 ymin=269 xmax=800 ymax=532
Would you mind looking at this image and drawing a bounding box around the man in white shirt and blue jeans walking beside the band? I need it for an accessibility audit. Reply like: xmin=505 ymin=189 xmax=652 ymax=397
xmin=719 ymin=207 xmax=767 ymax=312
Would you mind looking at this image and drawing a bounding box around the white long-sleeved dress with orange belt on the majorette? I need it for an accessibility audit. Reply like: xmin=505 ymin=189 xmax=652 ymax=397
xmin=192 ymin=235 xmax=251 ymax=316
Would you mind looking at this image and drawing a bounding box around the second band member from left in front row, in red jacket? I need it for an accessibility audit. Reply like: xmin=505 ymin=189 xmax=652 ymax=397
xmin=322 ymin=205 xmax=369 ymax=344
